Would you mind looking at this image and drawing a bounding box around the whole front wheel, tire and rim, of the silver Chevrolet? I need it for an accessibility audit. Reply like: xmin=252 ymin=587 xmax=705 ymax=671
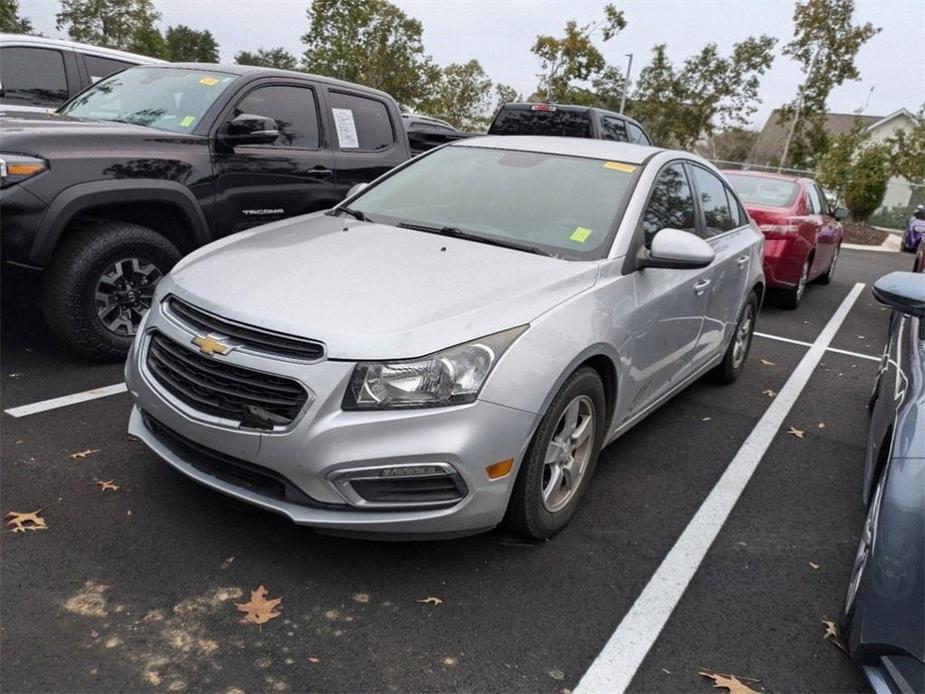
xmin=503 ymin=367 xmax=607 ymax=540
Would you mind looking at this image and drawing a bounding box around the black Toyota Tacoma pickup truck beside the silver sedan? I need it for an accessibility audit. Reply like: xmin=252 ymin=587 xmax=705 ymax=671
xmin=0 ymin=64 xmax=410 ymax=359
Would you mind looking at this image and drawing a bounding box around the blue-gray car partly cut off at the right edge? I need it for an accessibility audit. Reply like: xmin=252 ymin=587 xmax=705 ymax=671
xmin=841 ymin=272 xmax=925 ymax=693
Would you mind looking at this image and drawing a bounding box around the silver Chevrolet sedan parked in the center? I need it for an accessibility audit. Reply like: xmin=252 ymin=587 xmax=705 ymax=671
xmin=126 ymin=136 xmax=764 ymax=538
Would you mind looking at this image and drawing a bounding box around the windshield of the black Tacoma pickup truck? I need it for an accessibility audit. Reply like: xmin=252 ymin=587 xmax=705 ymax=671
xmin=59 ymin=67 xmax=236 ymax=133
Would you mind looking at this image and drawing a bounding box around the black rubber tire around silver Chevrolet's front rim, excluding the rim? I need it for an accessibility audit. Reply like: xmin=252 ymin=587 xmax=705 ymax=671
xmin=505 ymin=367 xmax=608 ymax=539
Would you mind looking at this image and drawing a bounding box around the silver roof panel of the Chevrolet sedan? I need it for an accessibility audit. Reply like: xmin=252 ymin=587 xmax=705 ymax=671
xmin=449 ymin=135 xmax=664 ymax=164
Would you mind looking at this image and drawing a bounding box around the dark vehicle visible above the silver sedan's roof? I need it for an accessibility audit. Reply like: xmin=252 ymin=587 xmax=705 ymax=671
xmin=488 ymin=104 xmax=652 ymax=145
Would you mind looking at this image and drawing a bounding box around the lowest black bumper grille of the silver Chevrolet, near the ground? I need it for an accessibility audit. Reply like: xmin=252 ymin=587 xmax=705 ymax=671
xmin=142 ymin=412 xmax=337 ymax=508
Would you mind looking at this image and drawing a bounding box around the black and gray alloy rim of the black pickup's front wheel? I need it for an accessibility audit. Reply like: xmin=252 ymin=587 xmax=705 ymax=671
xmin=94 ymin=257 xmax=162 ymax=336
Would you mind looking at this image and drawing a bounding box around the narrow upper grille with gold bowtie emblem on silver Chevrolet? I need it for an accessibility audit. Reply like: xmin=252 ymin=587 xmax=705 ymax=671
xmin=167 ymin=296 xmax=324 ymax=361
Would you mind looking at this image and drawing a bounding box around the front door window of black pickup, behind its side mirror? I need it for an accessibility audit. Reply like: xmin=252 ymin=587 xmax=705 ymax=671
xmin=231 ymin=85 xmax=320 ymax=149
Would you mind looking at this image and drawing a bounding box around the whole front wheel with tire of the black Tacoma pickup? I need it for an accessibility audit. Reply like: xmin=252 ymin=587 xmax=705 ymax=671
xmin=42 ymin=222 xmax=180 ymax=361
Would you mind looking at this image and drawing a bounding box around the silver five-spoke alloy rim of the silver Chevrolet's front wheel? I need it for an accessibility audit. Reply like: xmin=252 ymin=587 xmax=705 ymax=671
xmin=542 ymin=395 xmax=595 ymax=513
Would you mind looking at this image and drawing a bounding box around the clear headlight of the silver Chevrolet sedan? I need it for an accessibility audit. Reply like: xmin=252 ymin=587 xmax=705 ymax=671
xmin=343 ymin=325 xmax=527 ymax=410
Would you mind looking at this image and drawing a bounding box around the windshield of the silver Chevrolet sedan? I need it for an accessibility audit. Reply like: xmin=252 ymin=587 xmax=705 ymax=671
xmin=350 ymin=146 xmax=639 ymax=259
